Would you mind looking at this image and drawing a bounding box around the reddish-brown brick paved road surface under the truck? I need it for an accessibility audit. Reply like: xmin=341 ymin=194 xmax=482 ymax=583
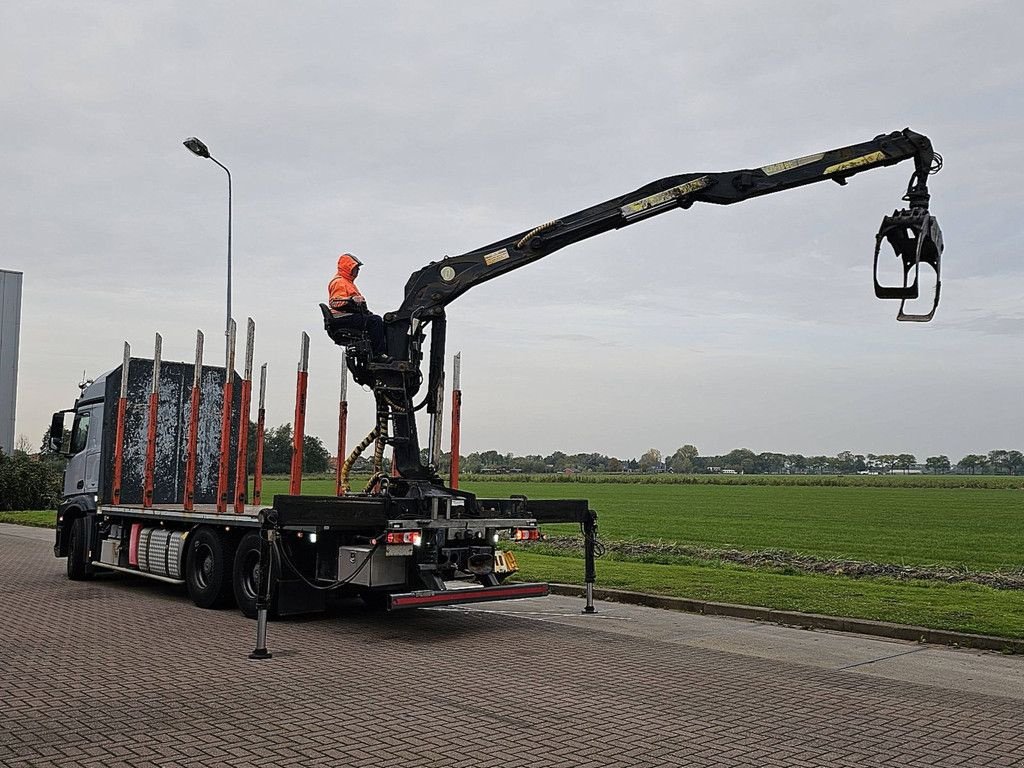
xmin=6 ymin=532 xmax=1024 ymax=768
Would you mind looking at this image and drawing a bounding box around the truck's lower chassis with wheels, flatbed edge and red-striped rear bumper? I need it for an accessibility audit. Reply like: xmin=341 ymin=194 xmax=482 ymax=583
xmin=54 ymin=495 xmax=596 ymax=617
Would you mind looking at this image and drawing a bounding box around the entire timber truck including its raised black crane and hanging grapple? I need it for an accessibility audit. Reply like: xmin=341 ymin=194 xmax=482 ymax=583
xmin=50 ymin=129 xmax=943 ymax=620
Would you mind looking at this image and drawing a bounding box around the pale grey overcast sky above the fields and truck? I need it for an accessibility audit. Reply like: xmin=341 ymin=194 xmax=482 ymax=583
xmin=0 ymin=0 xmax=1024 ymax=461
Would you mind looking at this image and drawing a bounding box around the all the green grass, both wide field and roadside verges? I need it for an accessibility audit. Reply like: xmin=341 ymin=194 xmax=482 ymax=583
xmin=9 ymin=476 xmax=1024 ymax=638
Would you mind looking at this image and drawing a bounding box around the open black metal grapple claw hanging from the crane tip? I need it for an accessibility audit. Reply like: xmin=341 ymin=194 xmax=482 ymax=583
xmin=874 ymin=208 xmax=942 ymax=323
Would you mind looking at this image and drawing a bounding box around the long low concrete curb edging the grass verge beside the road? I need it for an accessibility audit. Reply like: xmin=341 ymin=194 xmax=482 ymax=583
xmin=549 ymin=584 xmax=1024 ymax=653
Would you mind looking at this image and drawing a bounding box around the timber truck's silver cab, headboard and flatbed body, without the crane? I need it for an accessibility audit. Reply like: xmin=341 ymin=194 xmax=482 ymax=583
xmin=51 ymin=337 xmax=577 ymax=616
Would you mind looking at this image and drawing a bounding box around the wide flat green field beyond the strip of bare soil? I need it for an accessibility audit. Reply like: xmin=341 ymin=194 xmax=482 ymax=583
xmin=452 ymin=481 xmax=1024 ymax=570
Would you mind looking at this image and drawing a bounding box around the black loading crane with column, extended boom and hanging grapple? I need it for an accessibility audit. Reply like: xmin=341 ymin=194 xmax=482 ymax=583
xmin=322 ymin=128 xmax=942 ymax=500
